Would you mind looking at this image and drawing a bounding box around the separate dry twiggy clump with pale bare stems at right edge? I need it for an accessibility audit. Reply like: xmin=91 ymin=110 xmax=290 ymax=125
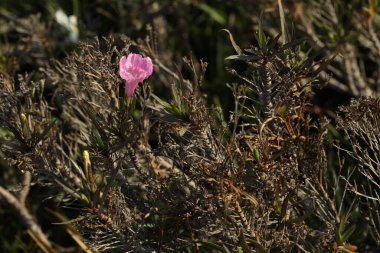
xmin=337 ymin=98 xmax=380 ymax=245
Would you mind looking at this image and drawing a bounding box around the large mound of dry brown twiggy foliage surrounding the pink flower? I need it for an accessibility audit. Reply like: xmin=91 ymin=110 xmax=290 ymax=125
xmin=1 ymin=32 xmax=338 ymax=252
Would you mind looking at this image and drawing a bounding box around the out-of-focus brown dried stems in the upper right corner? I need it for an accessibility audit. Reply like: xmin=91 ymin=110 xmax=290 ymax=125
xmin=297 ymin=0 xmax=380 ymax=96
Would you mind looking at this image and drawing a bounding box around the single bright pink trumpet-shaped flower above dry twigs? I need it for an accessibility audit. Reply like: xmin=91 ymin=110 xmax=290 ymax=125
xmin=119 ymin=53 xmax=153 ymax=97
